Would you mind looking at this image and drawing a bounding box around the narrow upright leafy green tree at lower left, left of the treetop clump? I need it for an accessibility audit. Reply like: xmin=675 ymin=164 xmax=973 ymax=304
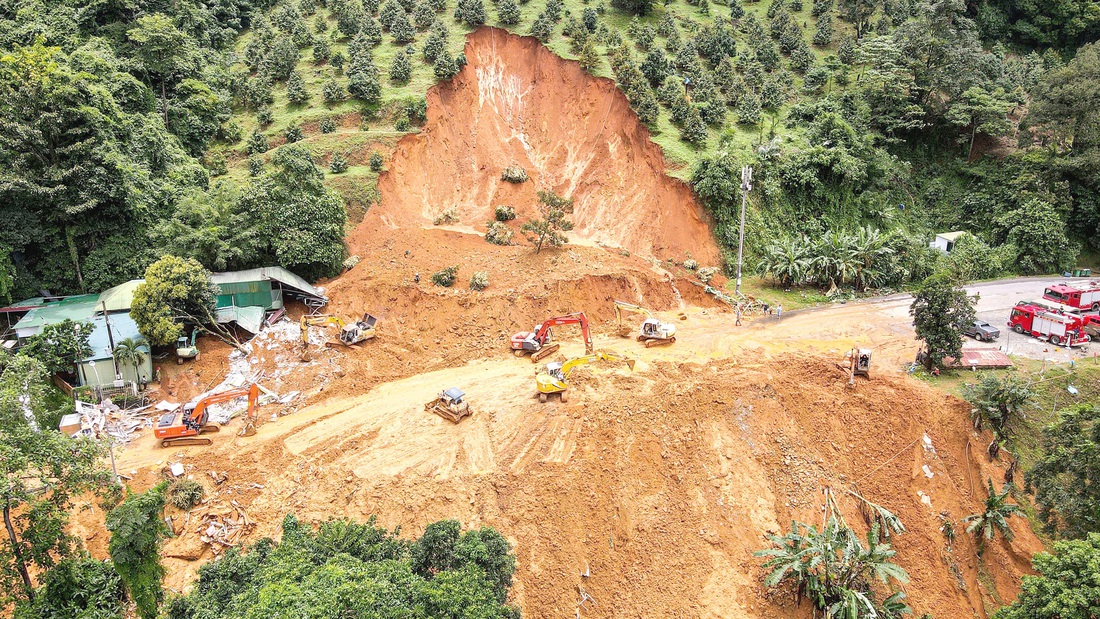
xmin=107 ymin=482 xmax=172 ymax=619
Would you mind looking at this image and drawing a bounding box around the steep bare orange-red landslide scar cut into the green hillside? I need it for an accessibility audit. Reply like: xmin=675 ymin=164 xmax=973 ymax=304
xmin=363 ymin=27 xmax=718 ymax=264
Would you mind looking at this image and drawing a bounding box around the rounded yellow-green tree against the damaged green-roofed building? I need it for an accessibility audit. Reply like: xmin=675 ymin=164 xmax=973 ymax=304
xmin=130 ymin=256 xmax=240 ymax=347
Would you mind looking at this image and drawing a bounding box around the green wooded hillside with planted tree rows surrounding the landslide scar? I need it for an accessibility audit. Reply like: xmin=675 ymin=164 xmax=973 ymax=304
xmin=0 ymin=0 xmax=1100 ymax=300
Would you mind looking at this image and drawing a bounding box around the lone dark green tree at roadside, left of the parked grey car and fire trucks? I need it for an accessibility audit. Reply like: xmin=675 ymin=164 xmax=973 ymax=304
xmin=909 ymin=273 xmax=975 ymax=371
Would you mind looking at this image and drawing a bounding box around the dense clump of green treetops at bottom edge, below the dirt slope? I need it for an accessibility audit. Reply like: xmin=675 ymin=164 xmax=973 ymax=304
xmin=166 ymin=516 xmax=519 ymax=619
